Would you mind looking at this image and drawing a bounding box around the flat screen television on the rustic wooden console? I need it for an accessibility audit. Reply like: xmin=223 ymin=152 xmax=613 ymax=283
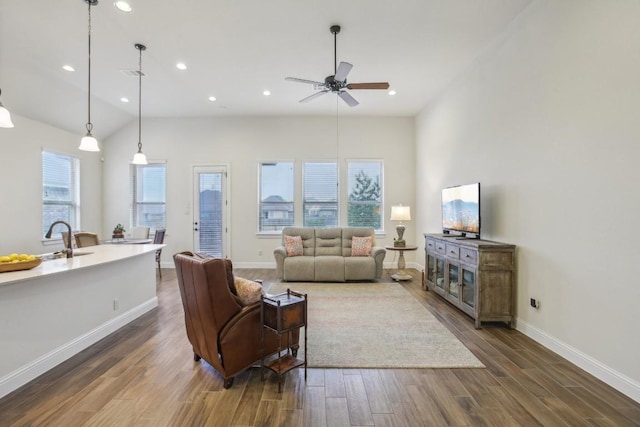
xmin=442 ymin=182 xmax=480 ymax=239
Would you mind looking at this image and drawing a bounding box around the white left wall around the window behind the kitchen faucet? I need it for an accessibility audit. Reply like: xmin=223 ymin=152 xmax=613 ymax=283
xmin=0 ymin=114 xmax=102 ymax=255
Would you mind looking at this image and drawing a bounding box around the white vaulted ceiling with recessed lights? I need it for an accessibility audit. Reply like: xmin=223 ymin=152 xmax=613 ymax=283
xmin=0 ymin=0 xmax=532 ymax=139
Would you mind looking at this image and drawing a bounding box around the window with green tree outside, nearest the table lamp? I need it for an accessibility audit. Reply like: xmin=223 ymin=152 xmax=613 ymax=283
xmin=347 ymin=161 xmax=384 ymax=231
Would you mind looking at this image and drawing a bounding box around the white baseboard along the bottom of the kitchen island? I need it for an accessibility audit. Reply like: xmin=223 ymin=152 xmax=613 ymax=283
xmin=0 ymin=297 xmax=158 ymax=398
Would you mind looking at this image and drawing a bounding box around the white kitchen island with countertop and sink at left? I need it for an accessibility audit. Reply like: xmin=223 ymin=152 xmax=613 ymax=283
xmin=0 ymin=244 xmax=164 ymax=397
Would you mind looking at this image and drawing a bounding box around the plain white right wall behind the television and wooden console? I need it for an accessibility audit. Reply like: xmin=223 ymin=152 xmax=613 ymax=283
xmin=416 ymin=0 xmax=640 ymax=400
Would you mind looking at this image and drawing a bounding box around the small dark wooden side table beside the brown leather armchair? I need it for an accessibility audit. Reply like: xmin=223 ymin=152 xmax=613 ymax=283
xmin=260 ymin=289 xmax=307 ymax=393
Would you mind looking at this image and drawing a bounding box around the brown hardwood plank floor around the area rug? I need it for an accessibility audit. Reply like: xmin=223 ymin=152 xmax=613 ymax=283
xmin=0 ymin=269 xmax=640 ymax=427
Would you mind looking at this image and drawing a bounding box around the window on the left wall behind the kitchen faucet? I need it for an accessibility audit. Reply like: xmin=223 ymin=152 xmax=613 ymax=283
xmin=42 ymin=151 xmax=80 ymax=237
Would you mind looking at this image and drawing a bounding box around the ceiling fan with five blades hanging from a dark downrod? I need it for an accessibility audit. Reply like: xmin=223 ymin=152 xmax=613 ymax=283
xmin=285 ymin=25 xmax=389 ymax=107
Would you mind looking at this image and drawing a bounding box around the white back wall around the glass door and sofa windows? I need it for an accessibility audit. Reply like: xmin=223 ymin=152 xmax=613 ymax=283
xmin=102 ymin=116 xmax=416 ymax=267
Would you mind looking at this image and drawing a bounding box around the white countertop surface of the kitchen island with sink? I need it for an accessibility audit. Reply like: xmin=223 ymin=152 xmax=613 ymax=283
xmin=0 ymin=244 xmax=165 ymax=286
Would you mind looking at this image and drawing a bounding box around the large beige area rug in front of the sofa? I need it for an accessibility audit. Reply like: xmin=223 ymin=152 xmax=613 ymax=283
xmin=267 ymin=283 xmax=484 ymax=368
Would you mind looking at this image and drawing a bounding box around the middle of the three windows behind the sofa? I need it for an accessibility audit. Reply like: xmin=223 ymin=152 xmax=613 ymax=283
xmin=302 ymin=162 xmax=339 ymax=227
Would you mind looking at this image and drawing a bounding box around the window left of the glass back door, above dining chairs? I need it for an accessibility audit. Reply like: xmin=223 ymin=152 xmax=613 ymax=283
xmin=131 ymin=162 xmax=167 ymax=230
